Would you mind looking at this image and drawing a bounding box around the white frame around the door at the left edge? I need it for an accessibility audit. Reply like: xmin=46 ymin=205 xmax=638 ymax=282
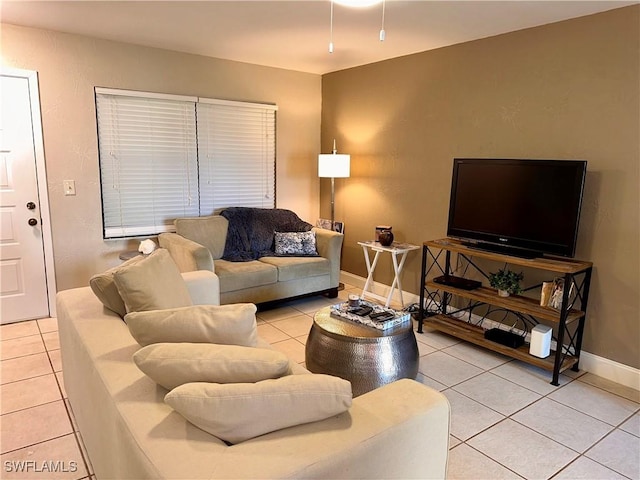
xmin=0 ymin=66 xmax=57 ymax=317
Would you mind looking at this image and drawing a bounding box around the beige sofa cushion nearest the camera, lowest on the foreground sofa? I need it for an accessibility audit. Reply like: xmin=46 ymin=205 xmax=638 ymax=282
xmin=164 ymin=375 xmax=352 ymax=443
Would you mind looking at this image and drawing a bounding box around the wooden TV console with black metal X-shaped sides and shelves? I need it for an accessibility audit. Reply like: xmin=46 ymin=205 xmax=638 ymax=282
xmin=418 ymin=238 xmax=593 ymax=386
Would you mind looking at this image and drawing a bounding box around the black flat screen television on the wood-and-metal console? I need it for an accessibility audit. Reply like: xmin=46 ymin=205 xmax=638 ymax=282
xmin=447 ymin=158 xmax=587 ymax=258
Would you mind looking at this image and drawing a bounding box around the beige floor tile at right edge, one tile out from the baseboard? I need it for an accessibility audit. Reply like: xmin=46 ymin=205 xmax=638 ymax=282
xmin=549 ymin=380 xmax=640 ymax=426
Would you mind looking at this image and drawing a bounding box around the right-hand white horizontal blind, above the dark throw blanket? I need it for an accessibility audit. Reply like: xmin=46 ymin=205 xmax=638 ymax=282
xmin=197 ymin=99 xmax=277 ymax=215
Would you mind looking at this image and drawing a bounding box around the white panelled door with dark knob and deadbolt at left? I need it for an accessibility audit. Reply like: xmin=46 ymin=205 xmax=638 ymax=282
xmin=0 ymin=73 xmax=50 ymax=324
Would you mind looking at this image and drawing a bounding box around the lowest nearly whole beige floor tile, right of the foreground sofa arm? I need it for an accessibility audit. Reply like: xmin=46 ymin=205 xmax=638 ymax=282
xmin=467 ymin=419 xmax=578 ymax=479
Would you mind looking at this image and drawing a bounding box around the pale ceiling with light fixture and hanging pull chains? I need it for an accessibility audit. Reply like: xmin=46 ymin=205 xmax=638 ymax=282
xmin=0 ymin=0 xmax=639 ymax=74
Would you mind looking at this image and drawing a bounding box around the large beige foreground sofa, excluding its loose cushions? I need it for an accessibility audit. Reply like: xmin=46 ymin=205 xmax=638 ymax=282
xmin=57 ymin=272 xmax=450 ymax=480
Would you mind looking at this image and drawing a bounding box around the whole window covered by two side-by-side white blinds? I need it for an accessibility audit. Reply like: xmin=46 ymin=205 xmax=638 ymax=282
xmin=95 ymin=88 xmax=277 ymax=238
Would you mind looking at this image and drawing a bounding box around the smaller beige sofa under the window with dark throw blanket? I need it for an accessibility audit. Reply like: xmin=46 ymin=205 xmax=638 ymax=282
xmin=158 ymin=215 xmax=343 ymax=304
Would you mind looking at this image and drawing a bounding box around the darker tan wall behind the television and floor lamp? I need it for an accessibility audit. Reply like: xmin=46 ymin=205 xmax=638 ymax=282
xmin=320 ymin=6 xmax=640 ymax=368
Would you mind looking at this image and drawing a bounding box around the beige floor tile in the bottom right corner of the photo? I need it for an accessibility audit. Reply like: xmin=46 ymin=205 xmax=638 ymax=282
xmin=585 ymin=430 xmax=640 ymax=479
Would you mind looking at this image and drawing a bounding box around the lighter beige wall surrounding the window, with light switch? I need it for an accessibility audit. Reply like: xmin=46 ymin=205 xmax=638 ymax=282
xmin=1 ymin=24 xmax=321 ymax=290
